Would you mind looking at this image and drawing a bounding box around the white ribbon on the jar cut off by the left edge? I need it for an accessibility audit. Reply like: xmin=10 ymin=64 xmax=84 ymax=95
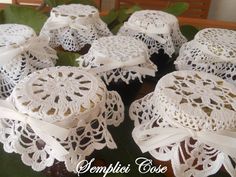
xmin=0 ymin=37 xmax=56 ymax=65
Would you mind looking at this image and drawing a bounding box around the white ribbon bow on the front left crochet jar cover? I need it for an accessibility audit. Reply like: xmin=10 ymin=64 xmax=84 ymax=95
xmin=0 ymin=100 xmax=69 ymax=160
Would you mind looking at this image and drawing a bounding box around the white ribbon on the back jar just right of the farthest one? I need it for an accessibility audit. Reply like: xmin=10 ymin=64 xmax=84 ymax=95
xmin=124 ymin=22 xmax=170 ymax=44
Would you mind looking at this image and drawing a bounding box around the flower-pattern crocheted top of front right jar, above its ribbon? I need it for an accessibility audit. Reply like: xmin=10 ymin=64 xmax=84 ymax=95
xmin=132 ymin=71 xmax=236 ymax=131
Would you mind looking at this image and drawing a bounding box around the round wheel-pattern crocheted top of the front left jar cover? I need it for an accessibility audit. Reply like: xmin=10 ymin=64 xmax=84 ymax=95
xmin=11 ymin=67 xmax=106 ymax=122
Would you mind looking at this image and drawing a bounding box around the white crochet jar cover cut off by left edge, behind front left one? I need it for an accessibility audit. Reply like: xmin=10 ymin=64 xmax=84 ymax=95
xmin=0 ymin=24 xmax=57 ymax=99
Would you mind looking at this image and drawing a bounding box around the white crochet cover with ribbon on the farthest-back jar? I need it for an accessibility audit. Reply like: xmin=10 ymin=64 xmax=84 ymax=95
xmin=41 ymin=4 xmax=112 ymax=51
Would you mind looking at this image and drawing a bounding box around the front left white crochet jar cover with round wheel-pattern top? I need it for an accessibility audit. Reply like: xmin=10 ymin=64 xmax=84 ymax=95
xmin=0 ymin=67 xmax=124 ymax=172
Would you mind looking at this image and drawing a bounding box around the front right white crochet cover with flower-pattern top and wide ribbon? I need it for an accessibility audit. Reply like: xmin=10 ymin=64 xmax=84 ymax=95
xmin=130 ymin=71 xmax=236 ymax=177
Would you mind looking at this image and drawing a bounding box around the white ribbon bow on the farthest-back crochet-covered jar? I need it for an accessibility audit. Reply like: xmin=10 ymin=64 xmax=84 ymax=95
xmin=41 ymin=12 xmax=99 ymax=31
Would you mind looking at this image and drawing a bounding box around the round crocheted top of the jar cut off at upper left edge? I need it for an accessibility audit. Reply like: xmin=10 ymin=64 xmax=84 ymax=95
xmin=0 ymin=24 xmax=36 ymax=48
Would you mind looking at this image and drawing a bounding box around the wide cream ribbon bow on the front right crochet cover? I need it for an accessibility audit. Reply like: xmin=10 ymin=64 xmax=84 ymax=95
xmin=132 ymin=124 xmax=236 ymax=158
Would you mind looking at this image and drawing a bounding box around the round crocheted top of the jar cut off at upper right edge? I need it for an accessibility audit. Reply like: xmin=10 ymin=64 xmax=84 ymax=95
xmin=194 ymin=28 xmax=236 ymax=60
